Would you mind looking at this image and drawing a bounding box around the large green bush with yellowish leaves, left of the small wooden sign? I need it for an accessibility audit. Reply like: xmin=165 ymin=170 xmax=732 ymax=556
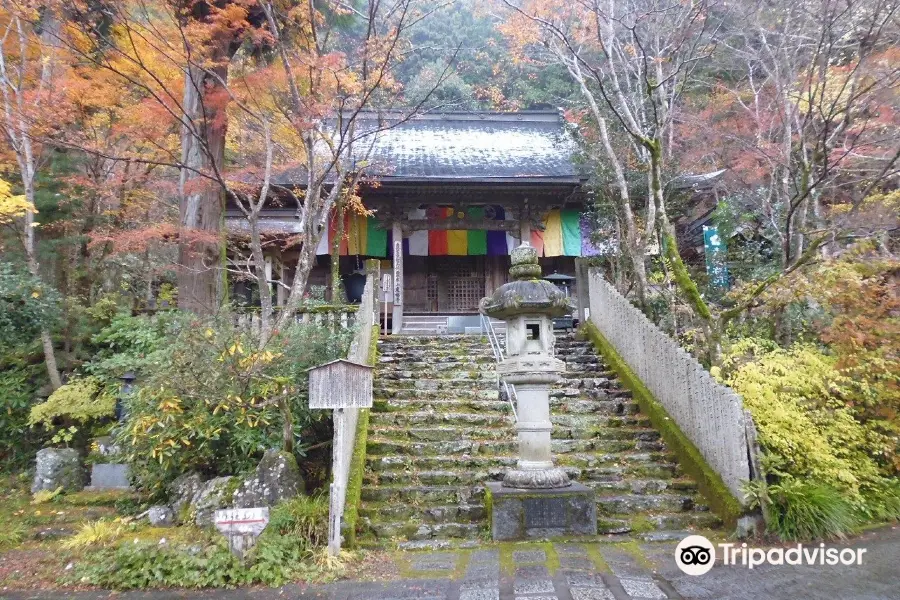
xmin=117 ymin=314 xmax=350 ymax=494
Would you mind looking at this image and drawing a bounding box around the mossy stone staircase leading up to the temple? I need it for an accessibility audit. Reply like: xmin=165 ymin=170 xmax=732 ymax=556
xmin=359 ymin=334 xmax=718 ymax=544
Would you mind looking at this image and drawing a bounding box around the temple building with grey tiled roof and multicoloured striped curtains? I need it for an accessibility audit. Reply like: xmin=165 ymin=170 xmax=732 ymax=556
xmin=226 ymin=111 xmax=600 ymax=331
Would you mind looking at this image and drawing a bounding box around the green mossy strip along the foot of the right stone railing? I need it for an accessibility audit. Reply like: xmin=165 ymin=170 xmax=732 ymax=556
xmin=580 ymin=322 xmax=745 ymax=528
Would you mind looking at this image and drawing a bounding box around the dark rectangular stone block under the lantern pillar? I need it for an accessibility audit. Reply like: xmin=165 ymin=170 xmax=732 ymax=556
xmin=485 ymin=482 xmax=597 ymax=541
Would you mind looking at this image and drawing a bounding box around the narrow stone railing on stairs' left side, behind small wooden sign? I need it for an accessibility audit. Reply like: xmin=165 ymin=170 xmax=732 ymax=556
xmin=328 ymin=261 xmax=380 ymax=555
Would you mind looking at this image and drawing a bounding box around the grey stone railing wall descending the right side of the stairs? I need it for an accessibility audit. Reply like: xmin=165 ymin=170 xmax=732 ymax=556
xmin=587 ymin=269 xmax=754 ymax=500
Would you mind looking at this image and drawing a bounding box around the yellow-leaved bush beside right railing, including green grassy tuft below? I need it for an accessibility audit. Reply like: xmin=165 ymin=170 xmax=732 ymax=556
xmin=716 ymin=338 xmax=900 ymax=539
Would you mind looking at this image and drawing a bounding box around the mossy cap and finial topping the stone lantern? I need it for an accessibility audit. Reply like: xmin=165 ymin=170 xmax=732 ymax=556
xmin=481 ymin=244 xmax=572 ymax=320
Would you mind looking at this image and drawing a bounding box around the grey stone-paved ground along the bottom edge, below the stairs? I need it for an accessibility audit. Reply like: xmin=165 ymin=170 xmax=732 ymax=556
xmin=0 ymin=526 xmax=900 ymax=600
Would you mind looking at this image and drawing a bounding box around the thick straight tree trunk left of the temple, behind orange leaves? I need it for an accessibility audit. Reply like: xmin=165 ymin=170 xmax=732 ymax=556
xmin=178 ymin=66 xmax=228 ymax=314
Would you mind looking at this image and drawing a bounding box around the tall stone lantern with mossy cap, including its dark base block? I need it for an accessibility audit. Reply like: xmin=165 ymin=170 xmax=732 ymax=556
xmin=481 ymin=244 xmax=597 ymax=540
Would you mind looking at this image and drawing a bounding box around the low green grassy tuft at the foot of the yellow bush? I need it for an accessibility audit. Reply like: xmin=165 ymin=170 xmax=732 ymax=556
xmin=748 ymin=478 xmax=859 ymax=541
